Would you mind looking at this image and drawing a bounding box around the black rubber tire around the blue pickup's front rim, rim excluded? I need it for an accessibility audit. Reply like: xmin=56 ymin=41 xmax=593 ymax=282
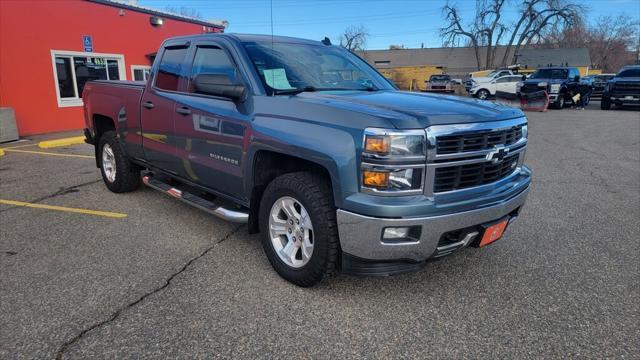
xmin=260 ymin=172 xmax=340 ymax=287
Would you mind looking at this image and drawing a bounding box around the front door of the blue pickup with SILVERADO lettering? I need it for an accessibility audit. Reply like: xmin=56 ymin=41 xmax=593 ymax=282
xmin=175 ymin=40 xmax=250 ymax=200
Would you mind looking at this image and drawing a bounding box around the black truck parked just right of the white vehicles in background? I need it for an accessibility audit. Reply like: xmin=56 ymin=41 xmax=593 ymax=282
xmin=519 ymin=67 xmax=580 ymax=109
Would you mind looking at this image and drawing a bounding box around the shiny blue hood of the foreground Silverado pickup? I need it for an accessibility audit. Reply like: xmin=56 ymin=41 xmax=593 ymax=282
xmin=292 ymin=91 xmax=524 ymax=129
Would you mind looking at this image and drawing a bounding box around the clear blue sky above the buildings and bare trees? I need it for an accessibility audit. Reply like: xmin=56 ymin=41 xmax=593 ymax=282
xmin=138 ymin=0 xmax=640 ymax=49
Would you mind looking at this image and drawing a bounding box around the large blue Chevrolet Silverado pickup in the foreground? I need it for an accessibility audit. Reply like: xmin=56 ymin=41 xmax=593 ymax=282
xmin=83 ymin=34 xmax=531 ymax=286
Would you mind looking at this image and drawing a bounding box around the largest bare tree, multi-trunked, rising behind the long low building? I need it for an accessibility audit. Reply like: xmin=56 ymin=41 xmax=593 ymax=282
xmin=440 ymin=0 xmax=583 ymax=69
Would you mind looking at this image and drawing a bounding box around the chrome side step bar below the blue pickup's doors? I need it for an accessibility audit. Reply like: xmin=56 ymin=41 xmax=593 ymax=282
xmin=142 ymin=174 xmax=249 ymax=223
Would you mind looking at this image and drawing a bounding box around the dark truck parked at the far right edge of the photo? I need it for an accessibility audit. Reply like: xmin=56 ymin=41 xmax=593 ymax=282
xmin=600 ymin=65 xmax=640 ymax=110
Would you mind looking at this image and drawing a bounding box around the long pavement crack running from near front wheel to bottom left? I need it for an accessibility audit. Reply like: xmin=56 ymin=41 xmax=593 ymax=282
xmin=55 ymin=225 xmax=244 ymax=360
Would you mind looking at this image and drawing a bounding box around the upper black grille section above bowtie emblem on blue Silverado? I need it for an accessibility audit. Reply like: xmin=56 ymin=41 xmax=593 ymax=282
xmin=436 ymin=125 xmax=522 ymax=154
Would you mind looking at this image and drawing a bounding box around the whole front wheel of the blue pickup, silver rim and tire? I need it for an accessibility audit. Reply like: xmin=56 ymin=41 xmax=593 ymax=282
xmin=260 ymin=172 xmax=340 ymax=287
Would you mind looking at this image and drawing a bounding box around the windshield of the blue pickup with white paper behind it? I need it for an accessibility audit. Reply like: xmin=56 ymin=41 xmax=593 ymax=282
xmin=243 ymin=42 xmax=393 ymax=94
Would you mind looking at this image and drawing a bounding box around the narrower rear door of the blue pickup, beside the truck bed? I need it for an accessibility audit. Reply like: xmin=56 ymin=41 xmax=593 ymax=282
xmin=140 ymin=43 xmax=189 ymax=173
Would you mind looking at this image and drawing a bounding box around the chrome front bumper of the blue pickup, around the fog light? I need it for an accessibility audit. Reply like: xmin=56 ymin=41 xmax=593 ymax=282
xmin=337 ymin=187 xmax=529 ymax=261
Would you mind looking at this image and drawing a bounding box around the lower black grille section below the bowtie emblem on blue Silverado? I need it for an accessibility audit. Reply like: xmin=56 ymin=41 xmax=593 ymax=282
xmin=433 ymin=155 xmax=518 ymax=192
